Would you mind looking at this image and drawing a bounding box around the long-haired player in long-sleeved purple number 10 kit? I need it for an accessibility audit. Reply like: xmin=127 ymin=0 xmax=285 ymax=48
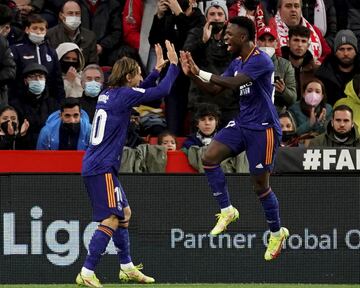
xmin=76 ymin=41 xmax=179 ymax=287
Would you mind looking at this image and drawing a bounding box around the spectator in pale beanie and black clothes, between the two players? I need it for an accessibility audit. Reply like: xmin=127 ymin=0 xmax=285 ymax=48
xmin=183 ymin=0 xmax=239 ymax=128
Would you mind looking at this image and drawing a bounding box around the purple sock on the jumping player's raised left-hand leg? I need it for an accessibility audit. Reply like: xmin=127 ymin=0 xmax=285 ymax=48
xmin=204 ymin=165 xmax=231 ymax=208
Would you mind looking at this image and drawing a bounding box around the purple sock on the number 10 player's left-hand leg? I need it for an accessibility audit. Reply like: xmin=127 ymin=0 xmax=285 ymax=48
xmin=84 ymin=224 xmax=114 ymax=271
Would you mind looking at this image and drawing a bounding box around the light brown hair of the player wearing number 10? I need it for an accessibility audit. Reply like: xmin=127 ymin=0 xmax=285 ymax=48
xmin=108 ymin=57 xmax=139 ymax=87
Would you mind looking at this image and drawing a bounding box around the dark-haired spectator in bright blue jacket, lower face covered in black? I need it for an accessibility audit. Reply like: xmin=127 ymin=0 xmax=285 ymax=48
xmin=36 ymin=97 xmax=91 ymax=150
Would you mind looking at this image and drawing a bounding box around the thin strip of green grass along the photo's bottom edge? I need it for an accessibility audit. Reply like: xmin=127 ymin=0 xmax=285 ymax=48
xmin=0 ymin=283 xmax=359 ymax=288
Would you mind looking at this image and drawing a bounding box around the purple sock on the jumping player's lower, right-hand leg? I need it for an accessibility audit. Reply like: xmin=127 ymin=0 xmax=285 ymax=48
xmin=258 ymin=188 xmax=280 ymax=232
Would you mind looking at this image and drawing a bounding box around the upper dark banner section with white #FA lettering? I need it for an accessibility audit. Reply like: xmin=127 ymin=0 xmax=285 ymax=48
xmin=274 ymin=147 xmax=360 ymax=174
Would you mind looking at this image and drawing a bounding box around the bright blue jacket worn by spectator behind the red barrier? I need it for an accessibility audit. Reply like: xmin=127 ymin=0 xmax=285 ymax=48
xmin=36 ymin=109 xmax=91 ymax=150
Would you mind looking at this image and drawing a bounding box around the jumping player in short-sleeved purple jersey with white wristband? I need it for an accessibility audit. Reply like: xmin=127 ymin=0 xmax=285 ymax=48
xmin=180 ymin=16 xmax=289 ymax=260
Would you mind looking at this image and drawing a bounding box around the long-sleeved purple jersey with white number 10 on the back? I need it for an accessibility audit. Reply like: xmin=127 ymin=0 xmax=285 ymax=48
xmin=82 ymin=64 xmax=179 ymax=176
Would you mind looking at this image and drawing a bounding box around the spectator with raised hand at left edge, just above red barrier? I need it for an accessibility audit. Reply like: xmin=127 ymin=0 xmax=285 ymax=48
xmin=0 ymin=105 xmax=29 ymax=150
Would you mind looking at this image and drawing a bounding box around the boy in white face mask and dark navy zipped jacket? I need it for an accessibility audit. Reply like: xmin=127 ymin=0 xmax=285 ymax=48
xmin=9 ymin=14 xmax=65 ymax=105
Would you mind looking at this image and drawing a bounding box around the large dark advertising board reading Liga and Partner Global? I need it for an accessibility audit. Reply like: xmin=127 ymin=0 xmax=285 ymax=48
xmin=0 ymin=174 xmax=360 ymax=284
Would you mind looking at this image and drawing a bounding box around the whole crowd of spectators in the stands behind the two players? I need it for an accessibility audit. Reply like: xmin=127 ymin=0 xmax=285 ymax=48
xmin=0 ymin=0 xmax=360 ymax=158
